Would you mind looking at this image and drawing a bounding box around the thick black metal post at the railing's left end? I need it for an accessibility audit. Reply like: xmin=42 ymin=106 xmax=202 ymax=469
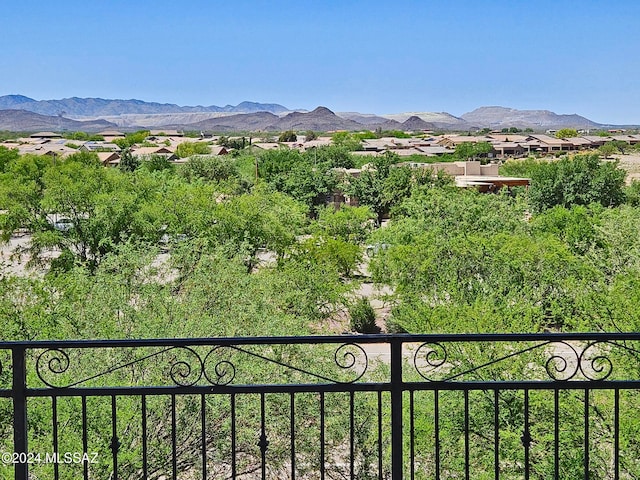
xmin=11 ymin=345 xmax=29 ymax=480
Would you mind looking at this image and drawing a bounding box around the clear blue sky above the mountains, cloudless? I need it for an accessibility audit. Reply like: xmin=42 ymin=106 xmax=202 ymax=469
xmin=0 ymin=0 xmax=640 ymax=124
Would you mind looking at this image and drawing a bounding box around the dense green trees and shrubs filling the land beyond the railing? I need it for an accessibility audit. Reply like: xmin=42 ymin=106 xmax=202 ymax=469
xmin=0 ymin=149 xmax=640 ymax=478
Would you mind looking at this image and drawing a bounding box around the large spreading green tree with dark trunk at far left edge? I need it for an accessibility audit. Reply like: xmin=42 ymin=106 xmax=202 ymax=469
xmin=1 ymin=160 xmax=165 ymax=270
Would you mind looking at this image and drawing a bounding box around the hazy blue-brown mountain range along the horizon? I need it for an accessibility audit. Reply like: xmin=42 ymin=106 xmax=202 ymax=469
xmin=0 ymin=95 xmax=620 ymax=132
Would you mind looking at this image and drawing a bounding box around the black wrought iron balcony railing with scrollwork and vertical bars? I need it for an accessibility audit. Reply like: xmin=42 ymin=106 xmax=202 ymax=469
xmin=0 ymin=333 xmax=640 ymax=480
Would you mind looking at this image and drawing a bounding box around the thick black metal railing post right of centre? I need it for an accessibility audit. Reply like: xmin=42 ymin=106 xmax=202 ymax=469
xmin=391 ymin=338 xmax=404 ymax=480
